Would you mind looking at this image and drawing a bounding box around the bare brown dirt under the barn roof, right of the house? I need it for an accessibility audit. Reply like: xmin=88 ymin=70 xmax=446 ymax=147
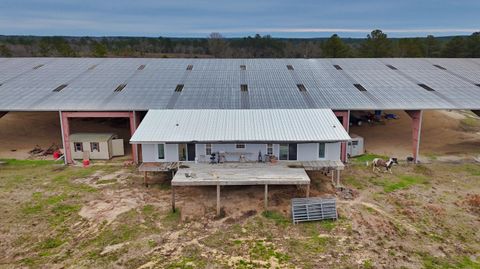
xmin=350 ymin=110 xmax=480 ymax=160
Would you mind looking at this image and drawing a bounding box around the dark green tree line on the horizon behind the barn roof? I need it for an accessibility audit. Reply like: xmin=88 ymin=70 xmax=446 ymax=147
xmin=0 ymin=30 xmax=480 ymax=58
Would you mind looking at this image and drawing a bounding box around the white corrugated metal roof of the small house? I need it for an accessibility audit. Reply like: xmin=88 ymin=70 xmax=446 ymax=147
xmin=130 ymin=109 xmax=350 ymax=143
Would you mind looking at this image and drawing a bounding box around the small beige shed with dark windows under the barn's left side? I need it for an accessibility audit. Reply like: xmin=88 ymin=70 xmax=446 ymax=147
xmin=70 ymin=133 xmax=125 ymax=160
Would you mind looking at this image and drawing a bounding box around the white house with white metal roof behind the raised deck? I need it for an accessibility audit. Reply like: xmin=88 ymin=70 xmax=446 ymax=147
xmin=130 ymin=109 xmax=350 ymax=163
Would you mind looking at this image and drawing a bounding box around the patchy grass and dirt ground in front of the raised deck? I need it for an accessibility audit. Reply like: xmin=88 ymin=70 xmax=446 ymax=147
xmin=0 ymin=158 xmax=480 ymax=268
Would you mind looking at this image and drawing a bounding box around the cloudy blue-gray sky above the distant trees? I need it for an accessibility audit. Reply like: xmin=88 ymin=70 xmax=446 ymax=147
xmin=0 ymin=0 xmax=480 ymax=38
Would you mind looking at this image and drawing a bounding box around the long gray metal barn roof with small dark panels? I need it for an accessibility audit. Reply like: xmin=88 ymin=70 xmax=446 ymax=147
xmin=0 ymin=58 xmax=480 ymax=111
